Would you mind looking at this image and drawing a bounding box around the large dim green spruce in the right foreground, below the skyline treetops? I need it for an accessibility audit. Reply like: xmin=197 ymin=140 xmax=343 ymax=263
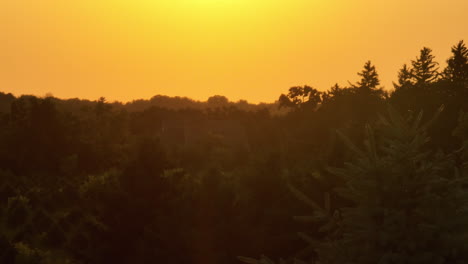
xmin=318 ymin=105 xmax=468 ymax=264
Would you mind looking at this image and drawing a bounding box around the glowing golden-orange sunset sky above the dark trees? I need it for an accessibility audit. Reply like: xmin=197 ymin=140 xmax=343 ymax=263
xmin=0 ymin=0 xmax=468 ymax=102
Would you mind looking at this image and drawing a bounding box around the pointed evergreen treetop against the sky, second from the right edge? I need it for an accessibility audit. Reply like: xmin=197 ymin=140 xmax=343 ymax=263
xmin=411 ymin=47 xmax=439 ymax=86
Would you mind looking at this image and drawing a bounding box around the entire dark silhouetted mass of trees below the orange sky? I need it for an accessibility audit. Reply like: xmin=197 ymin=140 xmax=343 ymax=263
xmin=0 ymin=41 xmax=468 ymax=264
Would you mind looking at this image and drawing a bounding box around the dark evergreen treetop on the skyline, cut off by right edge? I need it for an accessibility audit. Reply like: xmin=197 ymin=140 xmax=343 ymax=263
xmin=444 ymin=40 xmax=468 ymax=83
